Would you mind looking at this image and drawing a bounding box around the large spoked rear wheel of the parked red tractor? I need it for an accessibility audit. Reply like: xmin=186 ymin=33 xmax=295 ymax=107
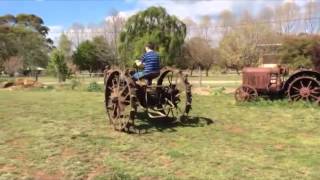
xmin=287 ymin=76 xmax=320 ymax=103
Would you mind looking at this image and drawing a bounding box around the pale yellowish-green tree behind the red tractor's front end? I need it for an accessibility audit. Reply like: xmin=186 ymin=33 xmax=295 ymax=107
xmin=219 ymin=24 xmax=278 ymax=69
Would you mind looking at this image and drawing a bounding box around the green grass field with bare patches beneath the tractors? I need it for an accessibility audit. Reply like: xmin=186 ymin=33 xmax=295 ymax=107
xmin=0 ymin=90 xmax=320 ymax=180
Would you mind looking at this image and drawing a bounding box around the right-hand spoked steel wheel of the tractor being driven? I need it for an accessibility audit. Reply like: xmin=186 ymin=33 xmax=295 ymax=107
xmin=157 ymin=70 xmax=192 ymax=118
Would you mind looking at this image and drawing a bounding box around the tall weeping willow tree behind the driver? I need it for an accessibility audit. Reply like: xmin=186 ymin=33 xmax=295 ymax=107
xmin=118 ymin=7 xmax=186 ymax=65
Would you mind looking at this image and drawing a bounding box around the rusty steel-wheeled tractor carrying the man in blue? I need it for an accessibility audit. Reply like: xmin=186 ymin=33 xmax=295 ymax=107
xmin=104 ymin=68 xmax=192 ymax=131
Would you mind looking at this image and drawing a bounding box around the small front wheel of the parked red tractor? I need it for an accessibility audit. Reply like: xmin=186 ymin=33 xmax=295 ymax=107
xmin=234 ymin=85 xmax=258 ymax=102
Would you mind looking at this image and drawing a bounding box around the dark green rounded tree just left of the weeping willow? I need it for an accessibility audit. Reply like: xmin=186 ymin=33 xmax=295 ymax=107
xmin=73 ymin=37 xmax=114 ymax=73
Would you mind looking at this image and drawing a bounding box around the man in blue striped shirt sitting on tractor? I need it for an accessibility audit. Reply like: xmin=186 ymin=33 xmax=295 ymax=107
xmin=132 ymin=43 xmax=160 ymax=85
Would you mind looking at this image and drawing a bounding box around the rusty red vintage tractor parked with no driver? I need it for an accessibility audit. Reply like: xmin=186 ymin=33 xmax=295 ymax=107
xmin=235 ymin=55 xmax=320 ymax=104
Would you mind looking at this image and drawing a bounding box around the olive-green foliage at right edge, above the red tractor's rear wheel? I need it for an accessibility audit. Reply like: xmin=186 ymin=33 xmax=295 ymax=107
xmin=280 ymin=35 xmax=320 ymax=71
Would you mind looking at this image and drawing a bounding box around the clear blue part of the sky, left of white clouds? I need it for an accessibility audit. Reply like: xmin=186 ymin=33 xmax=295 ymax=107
xmin=0 ymin=0 xmax=135 ymax=27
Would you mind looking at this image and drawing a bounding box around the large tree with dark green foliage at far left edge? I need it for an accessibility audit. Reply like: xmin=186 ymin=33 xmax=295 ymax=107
xmin=0 ymin=14 xmax=52 ymax=69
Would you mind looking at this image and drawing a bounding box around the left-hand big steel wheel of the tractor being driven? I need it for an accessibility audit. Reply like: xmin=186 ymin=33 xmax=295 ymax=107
xmin=105 ymin=71 xmax=136 ymax=131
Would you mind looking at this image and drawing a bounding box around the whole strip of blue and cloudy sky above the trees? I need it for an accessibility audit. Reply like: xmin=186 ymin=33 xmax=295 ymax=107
xmin=0 ymin=0 xmax=307 ymax=40
